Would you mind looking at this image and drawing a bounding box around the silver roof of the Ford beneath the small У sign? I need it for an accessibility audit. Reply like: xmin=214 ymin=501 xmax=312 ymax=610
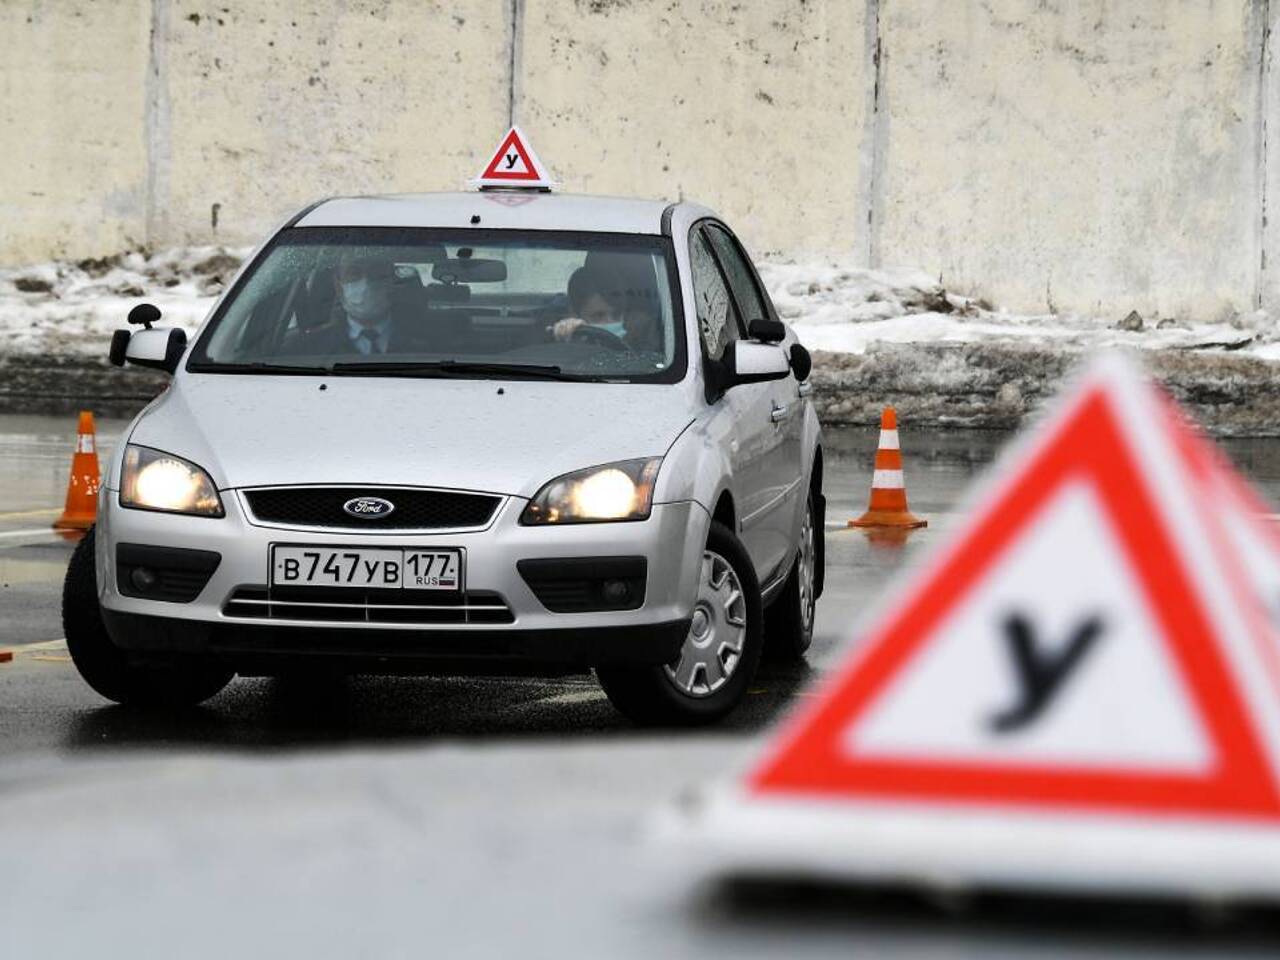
xmin=294 ymin=191 xmax=691 ymax=234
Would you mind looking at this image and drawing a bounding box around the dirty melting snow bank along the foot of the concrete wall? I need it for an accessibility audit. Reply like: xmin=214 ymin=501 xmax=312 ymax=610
xmin=0 ymin=247 xmax=1280 ymax=360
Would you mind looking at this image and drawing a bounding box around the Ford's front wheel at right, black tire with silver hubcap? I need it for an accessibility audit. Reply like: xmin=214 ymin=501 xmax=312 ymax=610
xmin=595 ymin=520 xmax=764 ymax=727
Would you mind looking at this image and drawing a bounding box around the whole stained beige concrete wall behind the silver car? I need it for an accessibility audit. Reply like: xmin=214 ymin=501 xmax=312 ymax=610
xmin=0 ymin=0 xmax=1280 ymax=317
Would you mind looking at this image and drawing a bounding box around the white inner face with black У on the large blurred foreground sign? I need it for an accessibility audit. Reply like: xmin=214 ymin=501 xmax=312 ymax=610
xmin=846 ymin=483 xmax=1213 ymax=772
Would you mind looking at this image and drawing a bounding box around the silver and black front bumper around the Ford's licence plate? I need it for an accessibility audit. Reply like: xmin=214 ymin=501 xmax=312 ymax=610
xmin=96 ymin=490 xmax=709 ymax=666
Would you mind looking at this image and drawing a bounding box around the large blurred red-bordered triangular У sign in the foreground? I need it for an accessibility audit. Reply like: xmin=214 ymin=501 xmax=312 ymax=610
xmin=746 ymin=360 xmax=1280 ymax=822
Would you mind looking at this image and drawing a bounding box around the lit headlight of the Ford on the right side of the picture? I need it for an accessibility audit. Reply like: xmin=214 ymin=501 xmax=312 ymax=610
xmin=520 ymin=457 xmax=662 ymax=525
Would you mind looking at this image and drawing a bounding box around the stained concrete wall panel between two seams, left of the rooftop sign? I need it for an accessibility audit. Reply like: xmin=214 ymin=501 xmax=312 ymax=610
xmin=162 ymin=0 xmax=511 ymax=244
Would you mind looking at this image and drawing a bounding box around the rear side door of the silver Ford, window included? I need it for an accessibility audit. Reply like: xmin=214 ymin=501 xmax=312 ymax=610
xmin=704 ymin=221 xmax=804 ymax=586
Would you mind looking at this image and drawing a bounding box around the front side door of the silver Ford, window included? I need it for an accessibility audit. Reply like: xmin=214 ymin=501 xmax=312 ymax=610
xmin=689 ymin=221 xmax=787 ymax=584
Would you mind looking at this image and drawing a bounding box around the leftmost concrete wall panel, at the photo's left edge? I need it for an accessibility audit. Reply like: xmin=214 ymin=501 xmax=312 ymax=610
xmin=0 ymin=0 xmax=151 ymax=264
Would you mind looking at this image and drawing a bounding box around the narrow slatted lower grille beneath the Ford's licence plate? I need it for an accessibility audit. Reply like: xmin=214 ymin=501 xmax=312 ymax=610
xmin=223 ymin=586 xmax=516 ymax=623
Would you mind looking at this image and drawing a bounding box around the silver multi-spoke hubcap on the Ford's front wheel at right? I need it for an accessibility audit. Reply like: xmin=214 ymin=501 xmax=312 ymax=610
xmin=663 ymin=552 xmax=747 ymax=696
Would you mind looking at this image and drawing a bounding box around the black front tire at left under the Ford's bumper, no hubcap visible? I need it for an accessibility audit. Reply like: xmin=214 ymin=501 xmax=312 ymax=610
xmin=63 ymin=527 xmax=236 ymax=708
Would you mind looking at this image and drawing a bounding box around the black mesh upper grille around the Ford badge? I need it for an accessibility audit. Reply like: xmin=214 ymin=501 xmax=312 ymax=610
xmin=244 ymin=486 xmax=502 ymax=532
